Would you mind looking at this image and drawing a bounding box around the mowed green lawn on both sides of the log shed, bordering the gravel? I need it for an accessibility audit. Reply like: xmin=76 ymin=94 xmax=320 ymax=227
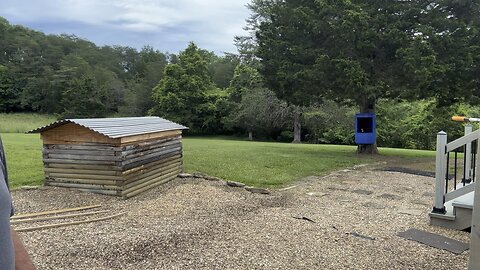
xmin=2 ymin=133 xmax=435 ymax=188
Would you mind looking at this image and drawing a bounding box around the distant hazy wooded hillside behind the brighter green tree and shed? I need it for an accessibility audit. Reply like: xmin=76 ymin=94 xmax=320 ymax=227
xmin=0 ymin=18 xmax=236 ymax=117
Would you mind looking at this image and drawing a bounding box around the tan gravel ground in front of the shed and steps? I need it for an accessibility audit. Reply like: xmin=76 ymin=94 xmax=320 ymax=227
xmin=12 ymin=167 xmax=469 ymax=270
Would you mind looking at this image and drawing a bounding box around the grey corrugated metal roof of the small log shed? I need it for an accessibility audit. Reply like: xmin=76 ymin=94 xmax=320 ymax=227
xmin=27 ymin=116 xmax=188 ymax=139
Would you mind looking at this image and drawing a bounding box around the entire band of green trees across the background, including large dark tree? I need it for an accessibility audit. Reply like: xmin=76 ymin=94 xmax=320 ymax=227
xmin=0 ymin=0 xmax=480 ymax=149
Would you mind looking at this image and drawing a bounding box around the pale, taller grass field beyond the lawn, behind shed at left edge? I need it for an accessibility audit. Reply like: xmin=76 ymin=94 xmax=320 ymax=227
xmin=0 ymin=113 xmax=57 ymax=133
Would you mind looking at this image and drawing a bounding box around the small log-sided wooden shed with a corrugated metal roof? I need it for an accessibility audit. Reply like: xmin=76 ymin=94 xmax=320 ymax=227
xmin=29 ymin=117 xmax=187 ymax=198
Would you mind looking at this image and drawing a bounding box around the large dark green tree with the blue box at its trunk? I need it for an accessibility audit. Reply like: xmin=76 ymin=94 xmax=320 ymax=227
xmin=250 ymin=0 xmax=480 ymax=152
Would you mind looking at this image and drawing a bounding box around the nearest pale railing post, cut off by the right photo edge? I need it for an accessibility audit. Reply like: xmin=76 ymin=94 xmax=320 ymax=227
xmin=468 ymin=137 xmax=480 ymax=270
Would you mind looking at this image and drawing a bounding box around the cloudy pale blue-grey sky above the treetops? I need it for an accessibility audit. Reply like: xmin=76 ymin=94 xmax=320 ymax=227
xmin=0 ymin=0 xmax=250 ymax=54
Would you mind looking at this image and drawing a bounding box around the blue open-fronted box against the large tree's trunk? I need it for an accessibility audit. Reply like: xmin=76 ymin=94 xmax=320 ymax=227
xmin=355 ymin=113 xmax=377 ymax=144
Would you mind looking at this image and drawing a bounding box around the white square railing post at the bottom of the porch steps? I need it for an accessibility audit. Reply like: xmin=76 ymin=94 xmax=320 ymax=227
xmin=432 ymin=131 xmax=447 ymax=214
